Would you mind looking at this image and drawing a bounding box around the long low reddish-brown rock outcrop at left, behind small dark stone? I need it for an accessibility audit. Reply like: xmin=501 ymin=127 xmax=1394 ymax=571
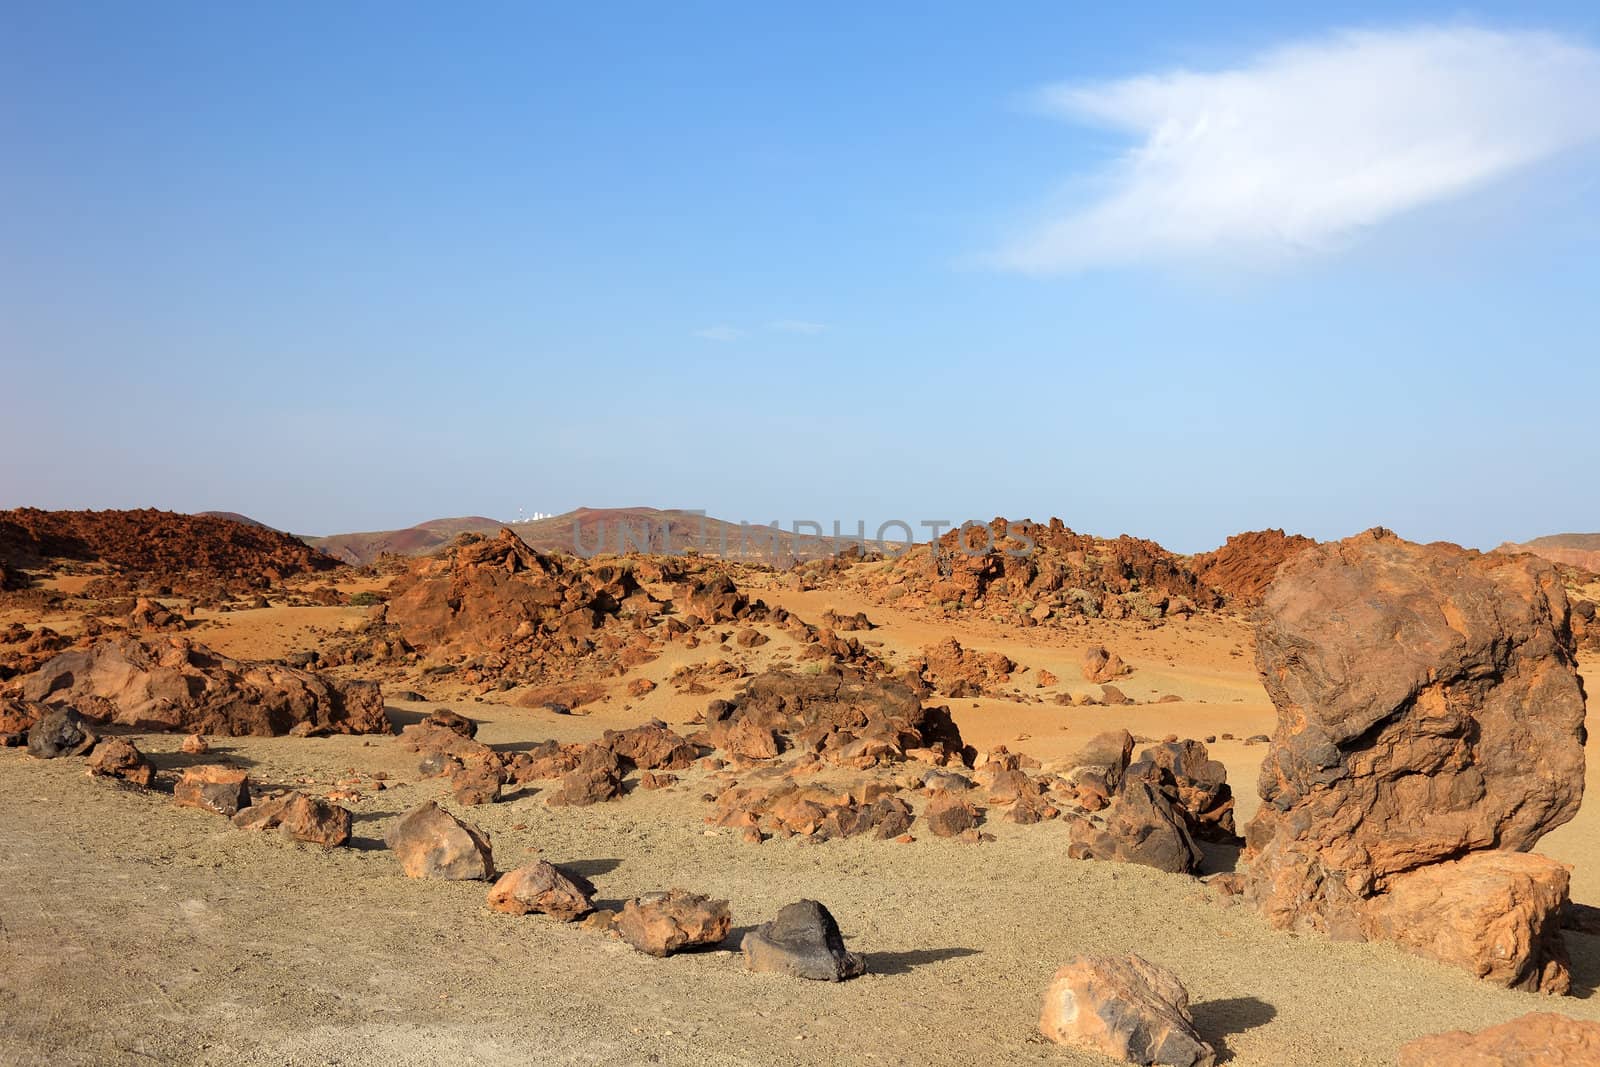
xmin=22 ymin=635 xmax=389 ymax=736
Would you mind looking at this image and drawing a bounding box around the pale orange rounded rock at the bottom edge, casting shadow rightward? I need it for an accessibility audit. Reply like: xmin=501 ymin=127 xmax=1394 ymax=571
xmin=1038 ymin=955 xmax=1216 ymax=1067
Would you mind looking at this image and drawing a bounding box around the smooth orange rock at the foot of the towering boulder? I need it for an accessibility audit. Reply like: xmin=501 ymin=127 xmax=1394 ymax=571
xmin=1362 ymin=851 xmax=1571 ymax=995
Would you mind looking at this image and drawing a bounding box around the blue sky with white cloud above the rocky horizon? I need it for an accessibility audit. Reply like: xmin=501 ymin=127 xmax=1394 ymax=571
xmin=0 ymin=3 xmax=1600 ymax=550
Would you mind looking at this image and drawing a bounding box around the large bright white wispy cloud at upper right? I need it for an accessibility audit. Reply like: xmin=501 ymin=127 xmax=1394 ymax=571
xmin=994 ymin=27 xmax=1600 ymax=272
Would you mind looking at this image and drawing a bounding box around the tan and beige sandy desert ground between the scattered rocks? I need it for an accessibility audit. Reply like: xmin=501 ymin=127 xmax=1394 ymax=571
xmin=0 ymin=566 xmax=1600 ymax=1067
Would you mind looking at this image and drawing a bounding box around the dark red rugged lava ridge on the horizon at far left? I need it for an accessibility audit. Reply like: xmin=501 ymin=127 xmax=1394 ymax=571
xmin=0 ymin=507 xmax=344 ymax=590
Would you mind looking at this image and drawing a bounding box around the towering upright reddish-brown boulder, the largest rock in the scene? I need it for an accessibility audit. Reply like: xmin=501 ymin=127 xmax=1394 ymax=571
xmin=1245 ymin=530 xmax=1584 ymax=987
